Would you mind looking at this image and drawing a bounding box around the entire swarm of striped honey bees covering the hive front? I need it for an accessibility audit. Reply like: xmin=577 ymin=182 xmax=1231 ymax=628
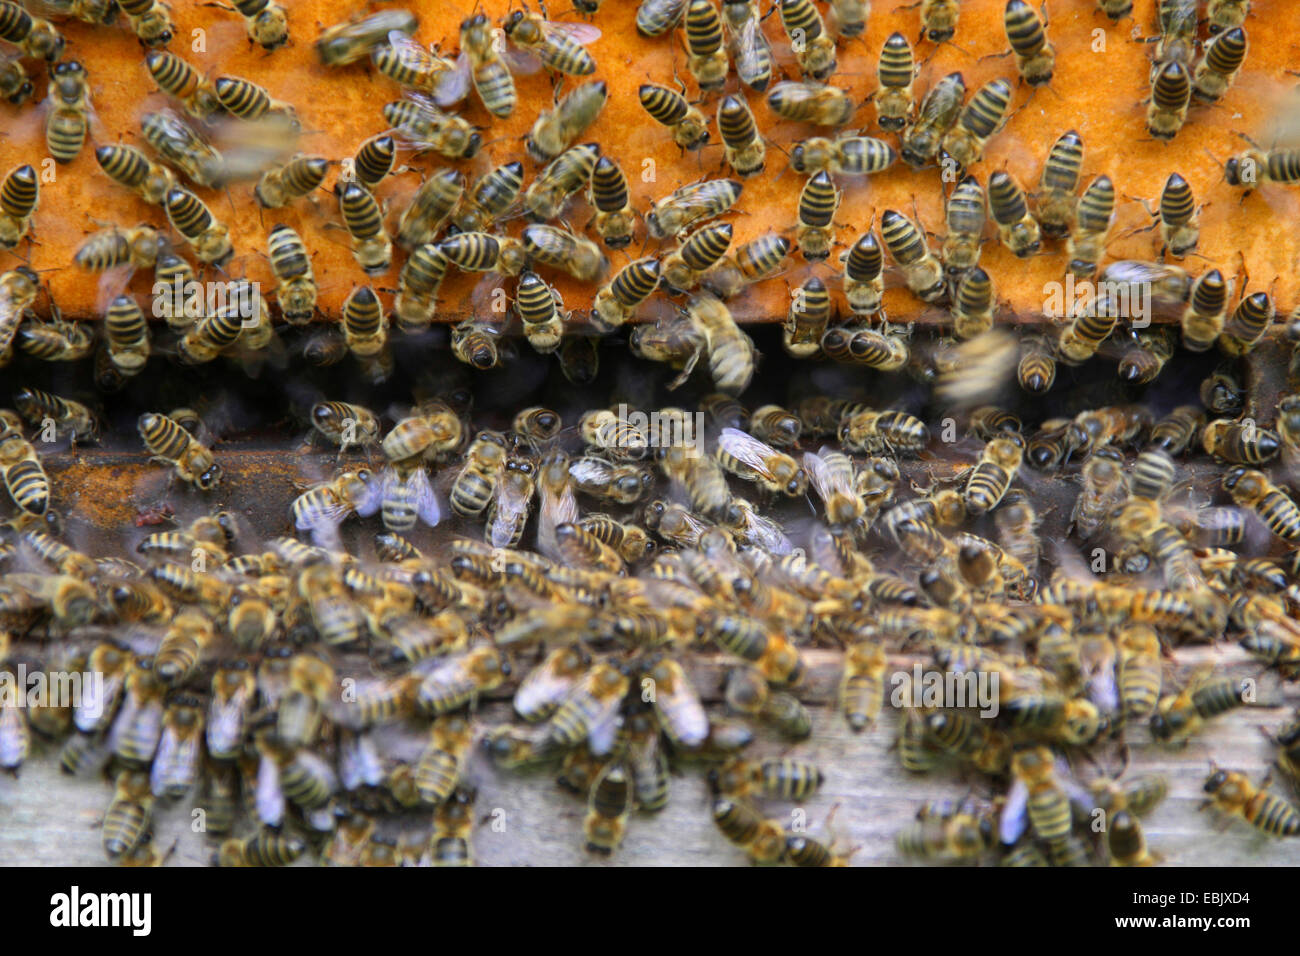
xmin=0 ymin=0 xmax=1300 ymax=866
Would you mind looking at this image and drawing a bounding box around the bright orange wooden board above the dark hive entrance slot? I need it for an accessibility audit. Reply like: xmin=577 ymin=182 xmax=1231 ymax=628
xmin=0 ymin=0 xmax=1300 ymax=321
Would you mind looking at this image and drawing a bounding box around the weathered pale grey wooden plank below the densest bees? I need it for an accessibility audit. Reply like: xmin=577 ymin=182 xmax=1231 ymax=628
xmin=0 ymin=646 xmax=1300 ymax=866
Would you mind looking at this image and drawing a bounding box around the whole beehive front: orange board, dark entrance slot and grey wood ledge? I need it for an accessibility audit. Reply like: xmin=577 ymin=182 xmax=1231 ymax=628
xmin=0 ymin=0 xmax=1300 ymax=865
